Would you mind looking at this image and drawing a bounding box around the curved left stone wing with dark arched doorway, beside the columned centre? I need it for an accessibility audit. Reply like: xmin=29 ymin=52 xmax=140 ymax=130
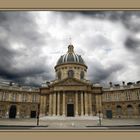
xmin=0 ymin=86 xmax=40 ymax=118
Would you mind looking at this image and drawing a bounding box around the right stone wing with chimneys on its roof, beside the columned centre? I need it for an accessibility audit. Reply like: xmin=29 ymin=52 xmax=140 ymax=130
xmin=102 ymin=84 xmax=140 ymax=118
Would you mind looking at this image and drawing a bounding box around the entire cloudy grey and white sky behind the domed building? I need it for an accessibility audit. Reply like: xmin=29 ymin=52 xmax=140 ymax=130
xmin=0 ymin=11 xmax=140 ymax=86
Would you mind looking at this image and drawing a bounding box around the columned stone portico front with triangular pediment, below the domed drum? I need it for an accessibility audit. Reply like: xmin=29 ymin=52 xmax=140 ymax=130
xmin=40 ymin=78 xmax=102 ymax=116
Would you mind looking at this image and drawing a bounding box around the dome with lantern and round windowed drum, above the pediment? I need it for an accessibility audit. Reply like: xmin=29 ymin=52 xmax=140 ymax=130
xmin=55 ymin=45 xmax=87 ymax=80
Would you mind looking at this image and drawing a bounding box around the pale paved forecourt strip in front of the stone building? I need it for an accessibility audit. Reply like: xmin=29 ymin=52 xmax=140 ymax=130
xmin=0 ymin=119 xmax=140 ymax=129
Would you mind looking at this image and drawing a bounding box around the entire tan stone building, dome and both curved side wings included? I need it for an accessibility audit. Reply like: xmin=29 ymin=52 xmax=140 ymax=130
xmin=0 ymin=45 xmax=140 ymax=118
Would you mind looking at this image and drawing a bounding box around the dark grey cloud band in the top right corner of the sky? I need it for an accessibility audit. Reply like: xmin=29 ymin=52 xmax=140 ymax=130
xmin=81 ymin=11 xmax=140 ymax=32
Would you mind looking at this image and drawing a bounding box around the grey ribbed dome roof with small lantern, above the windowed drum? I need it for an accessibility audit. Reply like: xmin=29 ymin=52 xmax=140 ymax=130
xmin=57 ymin=44 xmax=86 ymax=66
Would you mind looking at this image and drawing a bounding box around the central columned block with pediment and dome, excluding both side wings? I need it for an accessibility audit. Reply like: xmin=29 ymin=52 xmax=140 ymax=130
xmin=40 ymin=44 xmax=102 ymax=117
